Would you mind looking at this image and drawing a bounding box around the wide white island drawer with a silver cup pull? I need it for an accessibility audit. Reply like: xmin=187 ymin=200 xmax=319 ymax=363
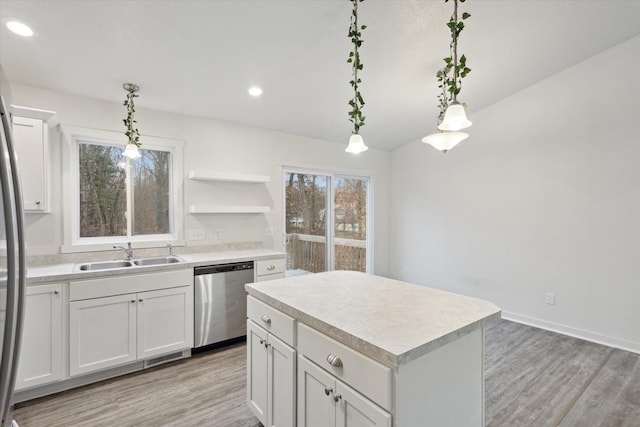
xmin=298 ymin=323 xmax=392 ymax=411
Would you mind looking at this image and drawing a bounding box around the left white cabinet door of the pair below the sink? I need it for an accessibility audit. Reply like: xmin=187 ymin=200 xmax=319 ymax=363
xmin=69 ymin=295 xmax=136 ymax=376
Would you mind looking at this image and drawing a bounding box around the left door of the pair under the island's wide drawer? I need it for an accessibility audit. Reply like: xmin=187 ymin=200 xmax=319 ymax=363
xmin=298 ymin=356 xmax=336 ymax=427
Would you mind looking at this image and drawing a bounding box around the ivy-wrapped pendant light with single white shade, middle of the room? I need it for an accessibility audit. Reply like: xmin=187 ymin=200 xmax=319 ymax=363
xmin=344 ymin=0 xmax=369 ymax=154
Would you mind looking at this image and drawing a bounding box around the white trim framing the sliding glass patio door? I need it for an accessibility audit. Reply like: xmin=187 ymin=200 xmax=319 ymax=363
xmin=280 ymin=164 xmax=375 ymax=274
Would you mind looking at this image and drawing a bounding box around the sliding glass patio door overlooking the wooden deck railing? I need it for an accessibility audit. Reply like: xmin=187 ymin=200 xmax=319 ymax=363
xmin=284 ymin=169 xmax=371 ymax=275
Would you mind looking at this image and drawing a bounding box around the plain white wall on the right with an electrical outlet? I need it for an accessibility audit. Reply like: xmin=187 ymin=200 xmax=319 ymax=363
xmin=389 ymin=37 xmax=640 ymax=352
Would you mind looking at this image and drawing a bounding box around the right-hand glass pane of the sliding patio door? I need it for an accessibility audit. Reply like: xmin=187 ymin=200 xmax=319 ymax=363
xmin=333 ymin=176 xmax=368 ymax=272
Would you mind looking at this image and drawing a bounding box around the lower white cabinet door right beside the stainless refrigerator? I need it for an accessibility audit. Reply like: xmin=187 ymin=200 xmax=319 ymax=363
xmin=16 ymin=284 xmax=62 ymax=390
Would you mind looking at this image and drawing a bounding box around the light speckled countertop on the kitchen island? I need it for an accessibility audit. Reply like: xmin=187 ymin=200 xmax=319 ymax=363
xmin=245 ymin=271 xmax=500 ymax=367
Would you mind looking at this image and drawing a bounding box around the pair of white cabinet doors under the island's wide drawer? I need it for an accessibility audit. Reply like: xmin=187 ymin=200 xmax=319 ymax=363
xmin=298 ymin=356 xmax=391 ymax=427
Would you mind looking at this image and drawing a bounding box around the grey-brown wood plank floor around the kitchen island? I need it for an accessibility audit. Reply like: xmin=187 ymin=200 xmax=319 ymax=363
xmin=14 ymin=320 xmax=640 ymax=427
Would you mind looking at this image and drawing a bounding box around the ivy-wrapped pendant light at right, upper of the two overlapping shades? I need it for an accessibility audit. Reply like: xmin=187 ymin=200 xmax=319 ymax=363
xmin=438 ymin=0 xmax=471 ymax=131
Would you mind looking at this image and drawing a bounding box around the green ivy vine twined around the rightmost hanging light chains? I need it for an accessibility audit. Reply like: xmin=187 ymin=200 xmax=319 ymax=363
xmin=437 ymin=0 xmax=471 ymax=119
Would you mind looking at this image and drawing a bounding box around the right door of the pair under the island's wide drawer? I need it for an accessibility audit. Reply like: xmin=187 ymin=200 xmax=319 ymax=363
xmin=335 ymin=381 xmax=391 ymax=427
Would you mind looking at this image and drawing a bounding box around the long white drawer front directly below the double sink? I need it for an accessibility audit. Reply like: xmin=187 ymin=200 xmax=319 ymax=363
xmin=69 ymin=267 xmax=193 ymax=301
